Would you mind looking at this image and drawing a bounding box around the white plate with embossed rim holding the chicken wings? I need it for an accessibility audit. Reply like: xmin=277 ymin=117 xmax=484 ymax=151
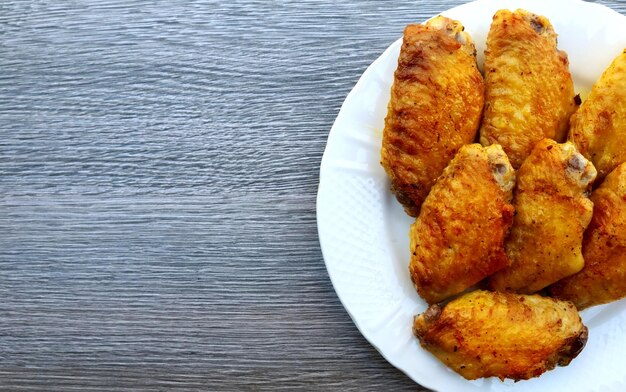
xmin=317 ymin=0 xmax=626 ymax=392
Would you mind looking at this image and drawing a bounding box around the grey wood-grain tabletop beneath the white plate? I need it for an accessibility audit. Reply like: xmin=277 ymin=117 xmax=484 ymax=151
xmin=0 ymin=0 xmax=626 ymax=391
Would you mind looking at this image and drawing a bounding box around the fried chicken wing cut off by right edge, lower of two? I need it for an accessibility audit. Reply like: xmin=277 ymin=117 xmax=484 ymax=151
xmin=550 ymin=163 xmax=626 ymax=309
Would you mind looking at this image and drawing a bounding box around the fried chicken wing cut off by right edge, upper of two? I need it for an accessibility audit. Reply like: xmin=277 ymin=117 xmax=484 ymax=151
xmin=569 ymin=50 xmax=626 ymax=181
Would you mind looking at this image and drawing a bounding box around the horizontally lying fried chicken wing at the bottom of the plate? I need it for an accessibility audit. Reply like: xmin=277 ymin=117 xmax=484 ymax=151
xmin=413 ymin=291 xmax=587 ymax=380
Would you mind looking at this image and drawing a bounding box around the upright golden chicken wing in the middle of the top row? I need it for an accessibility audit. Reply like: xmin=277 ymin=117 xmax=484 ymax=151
xmin=480 ymin=9 xmax=577 ymax=169
